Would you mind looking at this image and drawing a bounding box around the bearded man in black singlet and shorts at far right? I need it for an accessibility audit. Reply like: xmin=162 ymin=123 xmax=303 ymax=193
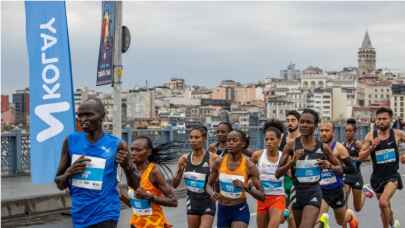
xmin=359 ymin=108 xmax=405 ymax=228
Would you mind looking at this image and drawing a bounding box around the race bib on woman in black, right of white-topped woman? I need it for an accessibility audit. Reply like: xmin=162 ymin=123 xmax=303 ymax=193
xmin=295 ymin=160 xmax=321 ymax=183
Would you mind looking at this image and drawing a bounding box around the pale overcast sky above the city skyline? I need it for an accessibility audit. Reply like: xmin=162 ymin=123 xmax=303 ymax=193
xmin=1 ymin=2 xmax=405 ymax=94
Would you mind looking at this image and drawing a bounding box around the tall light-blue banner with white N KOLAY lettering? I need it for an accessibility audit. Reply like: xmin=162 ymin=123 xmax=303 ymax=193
xmin=25 ymin=1 xmax=75 ymax=184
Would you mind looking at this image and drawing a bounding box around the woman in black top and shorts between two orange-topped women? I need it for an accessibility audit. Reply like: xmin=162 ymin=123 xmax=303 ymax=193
xmin=173 ymin=126 xmax=217 ymax=227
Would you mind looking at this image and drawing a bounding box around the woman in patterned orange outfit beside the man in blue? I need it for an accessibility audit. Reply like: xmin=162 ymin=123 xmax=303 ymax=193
xmin=124 ymin=136 xmax=177 ymax=228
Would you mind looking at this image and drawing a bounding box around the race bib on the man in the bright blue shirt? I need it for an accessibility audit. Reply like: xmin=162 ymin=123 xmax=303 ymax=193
xmin=72 ymin=154 xmax=106 ymax=190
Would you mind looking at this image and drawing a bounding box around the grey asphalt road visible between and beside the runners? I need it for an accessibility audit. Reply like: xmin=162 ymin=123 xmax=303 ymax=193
xmin=30 ymin=165 xmax=405 ymax=228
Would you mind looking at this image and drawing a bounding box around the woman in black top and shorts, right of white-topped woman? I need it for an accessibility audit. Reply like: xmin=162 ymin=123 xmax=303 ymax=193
xmin=276 ymin=109 xmax=339 ymax=228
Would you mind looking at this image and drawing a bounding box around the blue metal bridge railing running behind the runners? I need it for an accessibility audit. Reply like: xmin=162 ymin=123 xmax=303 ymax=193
xmin=1 ymin=125 xmax=370 ymax=176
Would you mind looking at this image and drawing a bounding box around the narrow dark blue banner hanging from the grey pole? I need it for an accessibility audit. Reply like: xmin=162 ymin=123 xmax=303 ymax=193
xmin=96 ymin=1 xmax=117 ymax=86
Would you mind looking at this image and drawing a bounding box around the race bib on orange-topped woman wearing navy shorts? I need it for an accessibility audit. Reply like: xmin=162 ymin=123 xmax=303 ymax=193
xmin=219 ymin=173 xmax=244 ymax=199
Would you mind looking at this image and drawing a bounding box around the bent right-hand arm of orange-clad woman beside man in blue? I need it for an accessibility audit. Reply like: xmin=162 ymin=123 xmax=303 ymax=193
xmin=150 ymin=166 xmax=177 ymax=207
